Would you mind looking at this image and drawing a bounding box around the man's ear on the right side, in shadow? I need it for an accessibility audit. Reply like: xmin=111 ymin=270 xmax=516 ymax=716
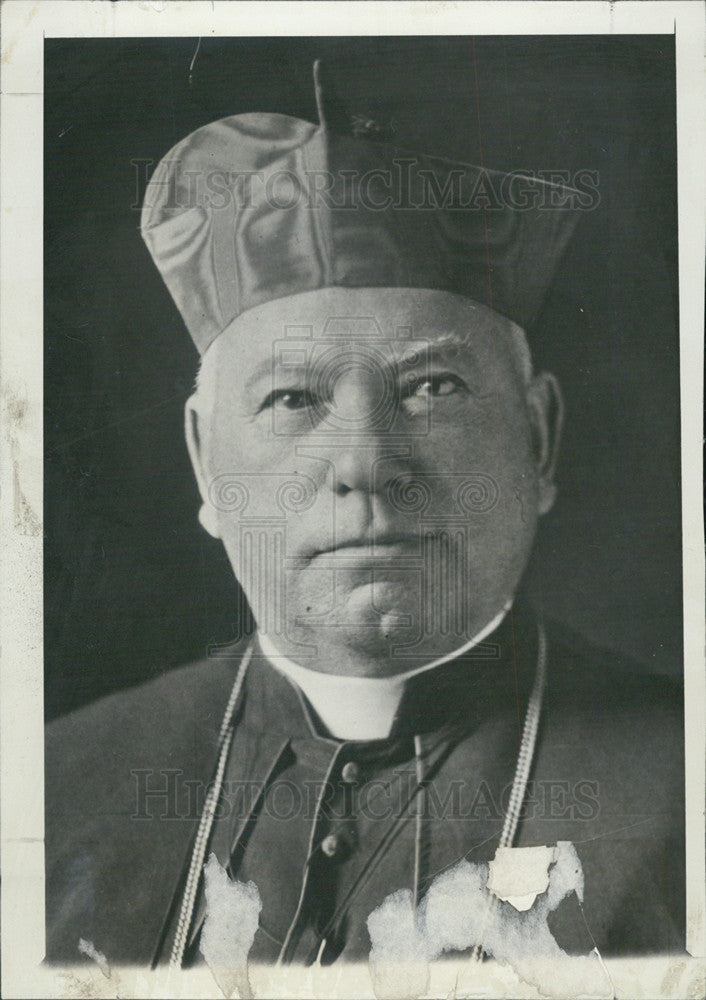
xmin=527 ymin=372 xmax=564 ymax=515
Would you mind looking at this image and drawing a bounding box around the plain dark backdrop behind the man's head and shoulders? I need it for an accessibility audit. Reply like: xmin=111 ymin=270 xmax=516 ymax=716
xmin=45 ymin=36 xmax=680 ymax=717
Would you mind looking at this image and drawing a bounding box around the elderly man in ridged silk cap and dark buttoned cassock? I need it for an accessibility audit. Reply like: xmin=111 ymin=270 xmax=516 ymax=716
xmin=47 ymin=78 xmax=684 ymax=965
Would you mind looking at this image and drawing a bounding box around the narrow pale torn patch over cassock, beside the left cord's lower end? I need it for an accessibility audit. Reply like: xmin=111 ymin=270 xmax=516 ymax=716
xmin=199 ymin=854 xmax=262 ymax=998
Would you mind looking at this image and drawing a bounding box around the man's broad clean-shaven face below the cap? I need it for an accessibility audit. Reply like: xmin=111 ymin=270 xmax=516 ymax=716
xmin=187 ymin=288 xmax=553 ymax=673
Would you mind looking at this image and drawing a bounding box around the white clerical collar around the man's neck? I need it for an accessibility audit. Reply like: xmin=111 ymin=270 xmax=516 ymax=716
xmin=258 ymin=601 xmax=512 ymax=740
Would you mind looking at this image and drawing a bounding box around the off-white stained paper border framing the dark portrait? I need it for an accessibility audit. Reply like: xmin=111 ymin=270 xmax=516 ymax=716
xmin=0 ymin=0 xmax=706 ymax=998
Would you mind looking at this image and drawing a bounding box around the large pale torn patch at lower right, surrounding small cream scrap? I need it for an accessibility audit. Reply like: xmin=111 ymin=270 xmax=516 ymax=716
xmin=368 ymin=841 xmax=613 ymax=1000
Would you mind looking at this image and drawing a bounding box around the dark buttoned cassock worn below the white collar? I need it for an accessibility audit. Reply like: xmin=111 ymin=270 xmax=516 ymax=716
xmin=46 ymin=608 xmax=685 ymax=964
